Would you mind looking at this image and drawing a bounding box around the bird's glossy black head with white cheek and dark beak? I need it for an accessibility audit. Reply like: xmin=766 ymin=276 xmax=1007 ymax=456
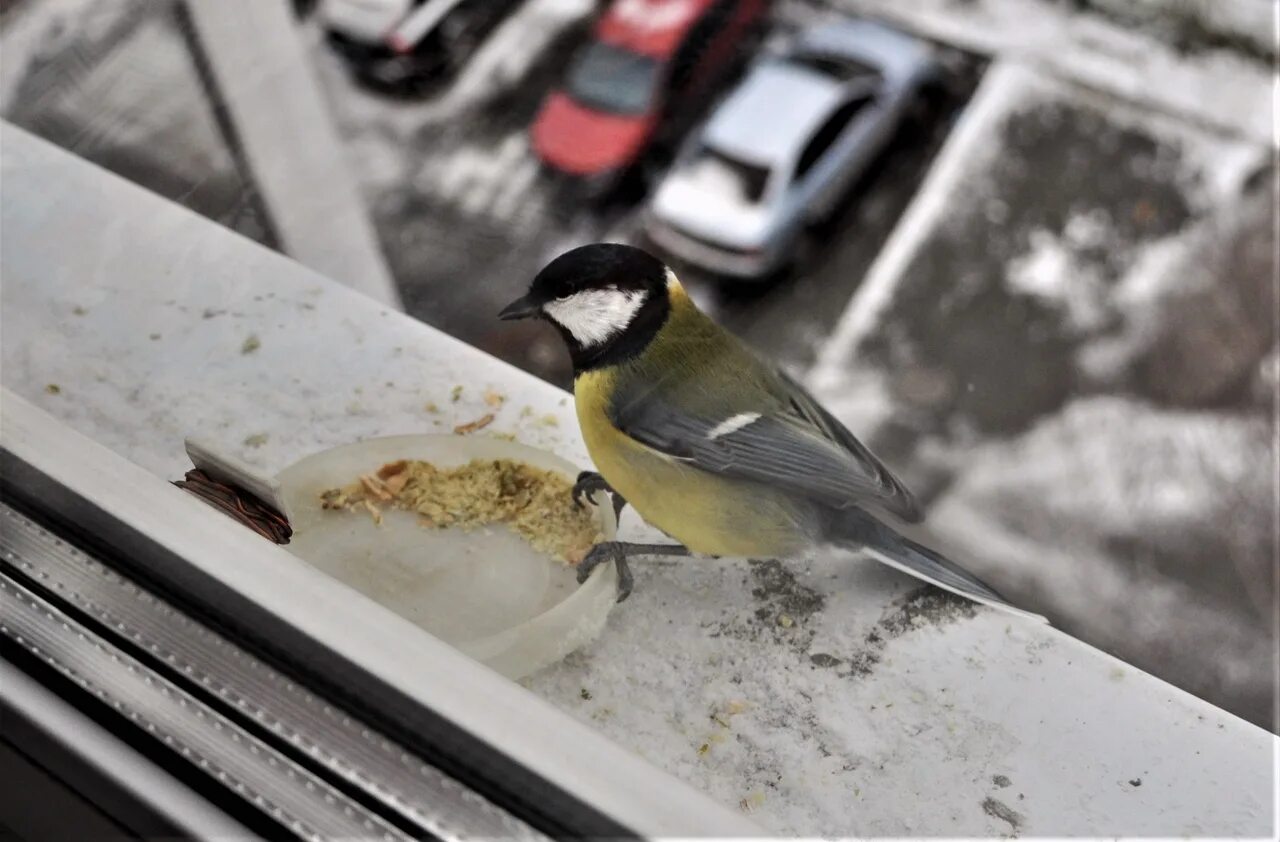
xmin=499 ymin=243 xmax=671 ymax=374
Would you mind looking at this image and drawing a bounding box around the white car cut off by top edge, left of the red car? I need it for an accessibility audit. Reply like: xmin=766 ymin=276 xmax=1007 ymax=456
xmin=319 ymin=0 xmax=520 ymax=93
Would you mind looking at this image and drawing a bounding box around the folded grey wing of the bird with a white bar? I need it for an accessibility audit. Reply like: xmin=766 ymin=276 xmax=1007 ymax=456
xmin=611 ymin=365 xmax=920 ymax=522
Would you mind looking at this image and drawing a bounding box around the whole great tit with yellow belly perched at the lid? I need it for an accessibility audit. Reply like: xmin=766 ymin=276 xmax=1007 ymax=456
xmin=499 ymin=243 xmax=1039 ymax=613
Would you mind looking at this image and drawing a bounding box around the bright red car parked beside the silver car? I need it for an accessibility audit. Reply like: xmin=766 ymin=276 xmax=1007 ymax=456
xmin=531 ymin=0 xmax=767 ymax=193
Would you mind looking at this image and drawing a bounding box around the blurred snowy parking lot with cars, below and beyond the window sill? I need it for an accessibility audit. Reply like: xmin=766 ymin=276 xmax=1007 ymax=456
xmin=0 ymin=0 xmax=1280 ymax=729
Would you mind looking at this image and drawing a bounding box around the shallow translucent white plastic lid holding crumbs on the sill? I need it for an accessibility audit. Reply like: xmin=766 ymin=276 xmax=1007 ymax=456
xmin=276 ymin=435 xmax=617 ymax=678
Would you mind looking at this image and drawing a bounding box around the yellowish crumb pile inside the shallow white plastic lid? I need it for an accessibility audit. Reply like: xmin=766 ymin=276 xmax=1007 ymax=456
xmin=320 ymin=459 xmax=602 ymax=564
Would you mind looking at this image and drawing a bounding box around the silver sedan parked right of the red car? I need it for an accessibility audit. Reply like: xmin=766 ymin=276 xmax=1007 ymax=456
xmin=645 ymin=20 xmax=941 ymax=279
